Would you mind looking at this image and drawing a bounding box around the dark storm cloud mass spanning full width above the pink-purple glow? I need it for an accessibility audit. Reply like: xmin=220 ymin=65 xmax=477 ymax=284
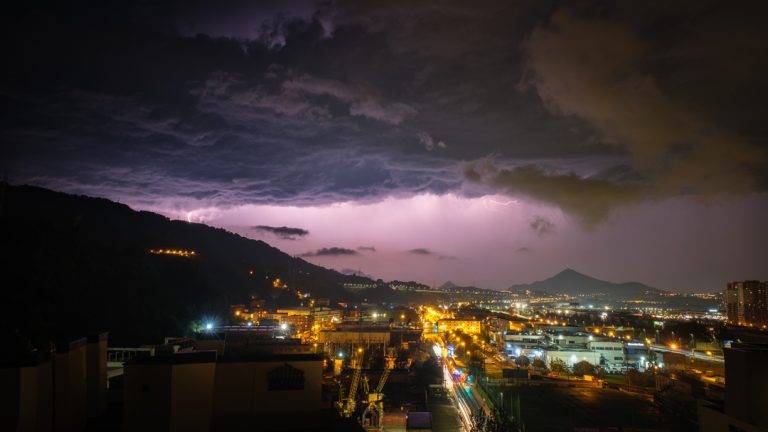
xmin=0 ymin=0 xmax=768 ymax=224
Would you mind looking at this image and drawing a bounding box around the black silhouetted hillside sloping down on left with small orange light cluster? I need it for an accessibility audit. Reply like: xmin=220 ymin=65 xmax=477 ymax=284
xmin=0 ymin=186 xmax=369 ymax=343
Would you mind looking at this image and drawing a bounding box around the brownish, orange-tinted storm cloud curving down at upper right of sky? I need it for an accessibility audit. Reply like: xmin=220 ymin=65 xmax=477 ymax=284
xmin=474 ymin=5 xmax=768 ymax=223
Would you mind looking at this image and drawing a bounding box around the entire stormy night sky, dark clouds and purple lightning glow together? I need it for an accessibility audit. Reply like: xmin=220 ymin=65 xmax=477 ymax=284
xmin=0 ymin=0 xmax=768 ymax=291
